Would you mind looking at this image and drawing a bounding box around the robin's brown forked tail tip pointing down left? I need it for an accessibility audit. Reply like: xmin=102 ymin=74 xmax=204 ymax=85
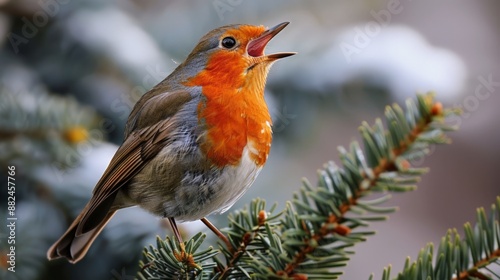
xmin=47 ymin=210 xmax=116 ymax=263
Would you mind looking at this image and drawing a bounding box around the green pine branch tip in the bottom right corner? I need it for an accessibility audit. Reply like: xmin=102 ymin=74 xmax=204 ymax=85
xmin=370 ymin=196 xmax=500 ymax=280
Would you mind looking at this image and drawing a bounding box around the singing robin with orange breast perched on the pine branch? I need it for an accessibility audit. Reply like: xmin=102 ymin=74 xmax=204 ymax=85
xmin=47 ymin=22 xmax=296 ymax=263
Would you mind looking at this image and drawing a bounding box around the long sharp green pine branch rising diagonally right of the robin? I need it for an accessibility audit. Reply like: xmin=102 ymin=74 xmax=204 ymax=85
xmin=264 ymin=94 xmax=456 ymax=279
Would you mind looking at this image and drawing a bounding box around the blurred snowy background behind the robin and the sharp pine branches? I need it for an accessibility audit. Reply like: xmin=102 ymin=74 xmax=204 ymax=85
xmin=0 ymin=0 xmax=500 ymax=279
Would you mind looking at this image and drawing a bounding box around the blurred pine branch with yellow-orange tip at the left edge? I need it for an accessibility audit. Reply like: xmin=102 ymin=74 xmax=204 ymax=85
xmin=0 ymin=86 xmax=102 ymax=168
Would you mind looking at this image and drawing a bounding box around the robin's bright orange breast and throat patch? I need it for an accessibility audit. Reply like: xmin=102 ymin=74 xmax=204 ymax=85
xmin=185 ymin=52 xmax=272 ymax=167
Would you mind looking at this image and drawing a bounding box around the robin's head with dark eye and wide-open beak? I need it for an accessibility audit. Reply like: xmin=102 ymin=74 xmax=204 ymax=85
xmin=183 ymin=22 xmax=295 ymax=90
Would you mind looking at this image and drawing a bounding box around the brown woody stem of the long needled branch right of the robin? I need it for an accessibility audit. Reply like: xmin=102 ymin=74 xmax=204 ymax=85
xmin=278 ymin=102 xmax=442 ymax=277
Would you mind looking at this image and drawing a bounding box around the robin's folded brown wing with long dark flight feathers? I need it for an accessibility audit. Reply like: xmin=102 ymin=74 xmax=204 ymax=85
xmin=76 ymin=91 xmax=192 ymax=236
